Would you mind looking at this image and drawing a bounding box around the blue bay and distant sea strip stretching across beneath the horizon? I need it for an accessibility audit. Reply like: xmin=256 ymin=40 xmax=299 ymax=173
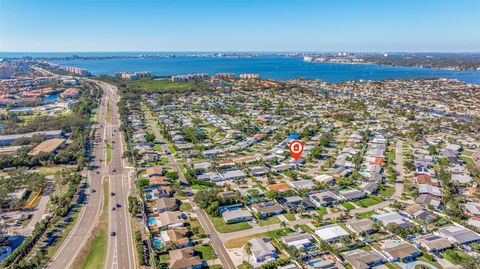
xmin=0 ymin=52 xmax=480 ymax=83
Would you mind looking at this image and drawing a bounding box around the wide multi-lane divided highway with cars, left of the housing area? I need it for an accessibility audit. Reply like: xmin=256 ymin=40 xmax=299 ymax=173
xmin=47 ymin=75 xmax=136 ymax=269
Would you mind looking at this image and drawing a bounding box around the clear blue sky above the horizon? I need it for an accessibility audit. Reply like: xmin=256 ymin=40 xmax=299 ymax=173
xmin=0 ymin=0 xmax=480 ymax=52
